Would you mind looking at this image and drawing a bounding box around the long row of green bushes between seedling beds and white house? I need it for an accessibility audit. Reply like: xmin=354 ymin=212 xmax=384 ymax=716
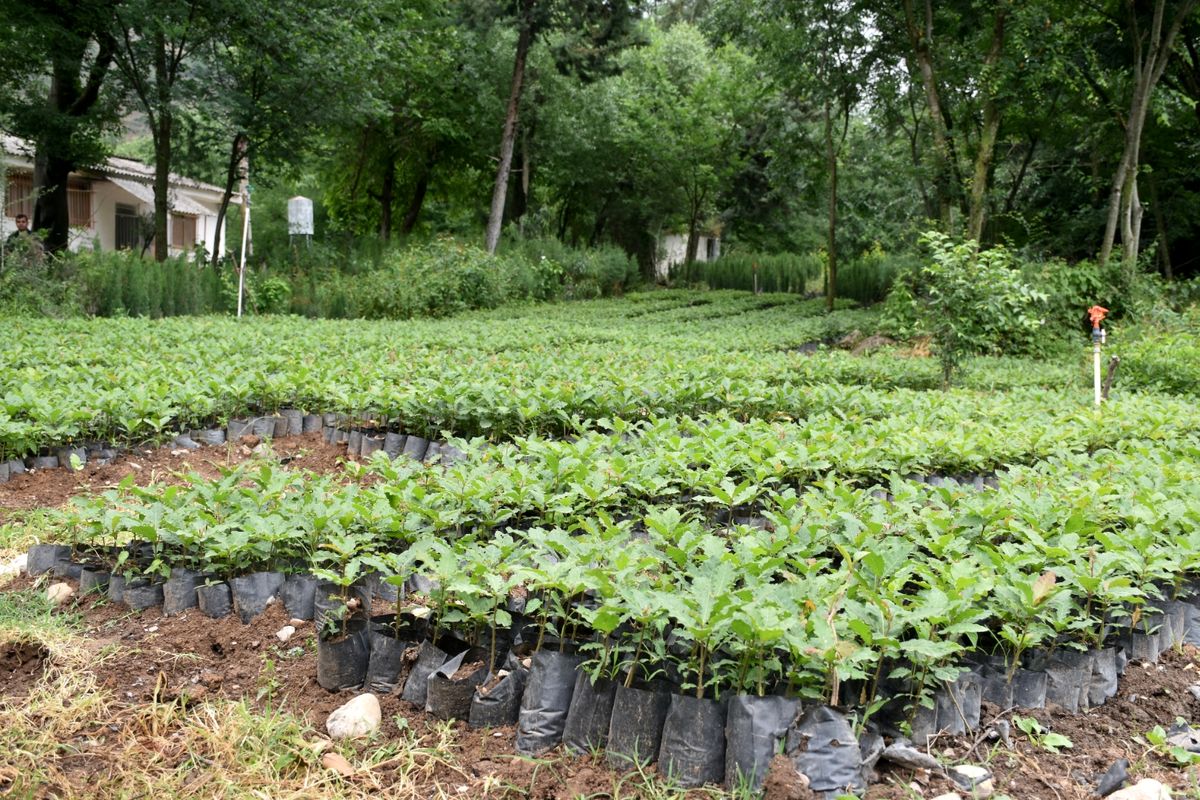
xmin=7 ymin=232 xmax=638 ymax=318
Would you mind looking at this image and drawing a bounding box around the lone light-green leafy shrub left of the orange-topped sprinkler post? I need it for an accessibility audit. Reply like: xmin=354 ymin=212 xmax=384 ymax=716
xmin=884 ymin=231 xmax=1048 ymax=385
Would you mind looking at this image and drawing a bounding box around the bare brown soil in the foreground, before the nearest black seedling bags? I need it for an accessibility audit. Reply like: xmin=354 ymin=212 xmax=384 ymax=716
xmin=7 ymin=577 xmax=1200 ymax=800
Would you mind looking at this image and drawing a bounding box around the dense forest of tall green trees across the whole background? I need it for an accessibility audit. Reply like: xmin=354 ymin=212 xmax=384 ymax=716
xmin=0 ymin=0 xmax=1200 ymax=287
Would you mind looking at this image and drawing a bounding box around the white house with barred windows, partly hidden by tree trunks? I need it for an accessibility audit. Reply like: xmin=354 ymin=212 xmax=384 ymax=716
xmin=0 ymin=137 xmax=241 ymax=255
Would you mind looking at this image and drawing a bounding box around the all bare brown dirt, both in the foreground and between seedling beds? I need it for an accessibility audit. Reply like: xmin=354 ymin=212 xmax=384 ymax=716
xmin=7 ymin=434 xmax=1200 ymax=800
